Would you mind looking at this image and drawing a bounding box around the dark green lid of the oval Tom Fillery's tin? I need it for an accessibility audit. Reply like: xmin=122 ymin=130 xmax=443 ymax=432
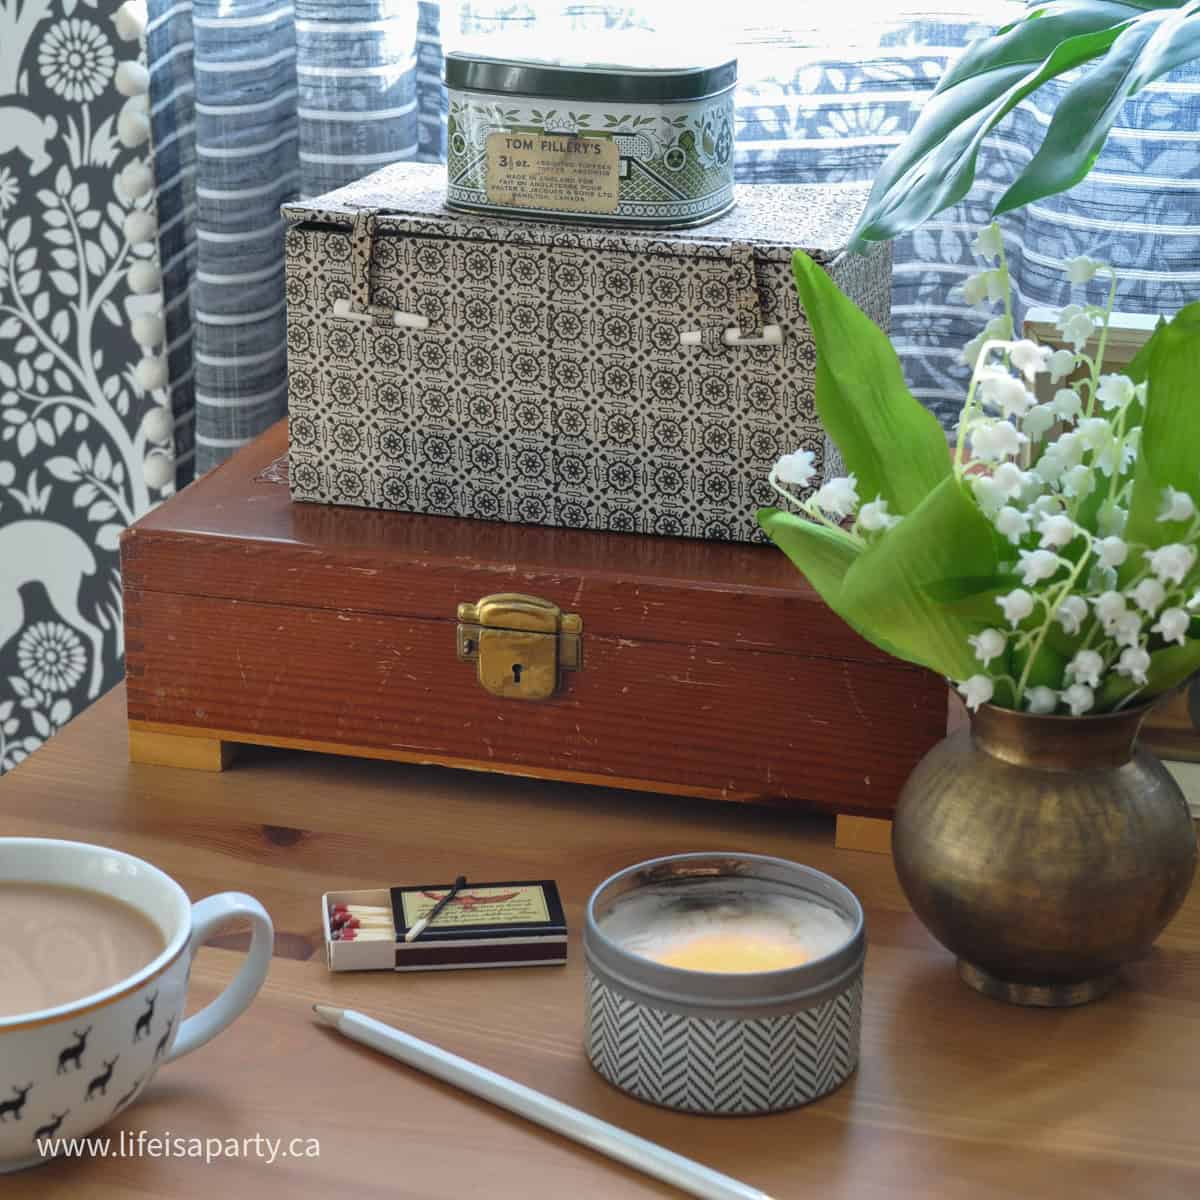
xmin=445 ymin=37 xmax=738 ymax=104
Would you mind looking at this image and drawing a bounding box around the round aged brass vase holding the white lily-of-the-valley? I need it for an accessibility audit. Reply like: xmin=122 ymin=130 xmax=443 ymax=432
xmin=892 ymin=706 xmax=1196 ymax=1007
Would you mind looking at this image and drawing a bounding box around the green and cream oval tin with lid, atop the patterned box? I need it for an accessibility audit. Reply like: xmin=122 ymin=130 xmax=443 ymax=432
xmin=445 ymin=50 xmax=737 ymax=228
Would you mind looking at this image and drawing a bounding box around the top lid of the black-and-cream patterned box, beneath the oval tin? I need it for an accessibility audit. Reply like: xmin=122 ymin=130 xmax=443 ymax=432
xmin=281 ymin=162 xmax=870 ymax=263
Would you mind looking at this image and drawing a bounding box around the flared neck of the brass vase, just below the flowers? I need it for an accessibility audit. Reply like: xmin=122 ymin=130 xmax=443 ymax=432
xmin=971 ymin=704 xmax=1150 ymax=770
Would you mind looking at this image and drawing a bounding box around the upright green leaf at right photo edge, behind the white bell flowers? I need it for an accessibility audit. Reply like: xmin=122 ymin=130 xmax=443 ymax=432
xmin=1121 ymin=304 xmax=1200 ymax=566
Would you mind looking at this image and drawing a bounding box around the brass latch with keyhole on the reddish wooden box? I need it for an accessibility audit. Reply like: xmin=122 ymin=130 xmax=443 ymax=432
xmin=458 ymin=592 xmax=583 ymax=700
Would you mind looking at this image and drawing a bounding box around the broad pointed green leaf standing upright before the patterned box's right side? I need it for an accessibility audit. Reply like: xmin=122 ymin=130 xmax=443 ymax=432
xmin=792 ymin=250 xmax=950 ymax=516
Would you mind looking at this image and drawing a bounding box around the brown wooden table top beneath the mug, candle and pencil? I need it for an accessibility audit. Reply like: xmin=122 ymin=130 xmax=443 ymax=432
xmin=0 ymin=689 xmax=1200 ymax=1200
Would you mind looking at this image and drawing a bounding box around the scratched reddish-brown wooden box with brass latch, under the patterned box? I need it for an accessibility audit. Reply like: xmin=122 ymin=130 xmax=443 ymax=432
xmin=121 ymin=422 xmax=946 ymax=815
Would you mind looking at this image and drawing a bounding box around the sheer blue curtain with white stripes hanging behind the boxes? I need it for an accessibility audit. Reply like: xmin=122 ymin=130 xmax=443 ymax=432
xmin=142 ymin=0 xmax=1200 ymax=472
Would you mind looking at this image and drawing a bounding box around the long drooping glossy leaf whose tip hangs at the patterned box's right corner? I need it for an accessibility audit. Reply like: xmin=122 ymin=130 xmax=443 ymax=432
xmin=852 ymin=0 xmax=1144 ymax=248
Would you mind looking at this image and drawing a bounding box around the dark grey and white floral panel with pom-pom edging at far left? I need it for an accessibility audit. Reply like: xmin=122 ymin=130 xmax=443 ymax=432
xmin=0 ymin=0 xmax=174 ymax=773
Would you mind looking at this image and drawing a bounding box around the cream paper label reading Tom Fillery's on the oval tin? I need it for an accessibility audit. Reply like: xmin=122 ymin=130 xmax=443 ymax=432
xmin=486 ymin=133 xmax=620 ymax=212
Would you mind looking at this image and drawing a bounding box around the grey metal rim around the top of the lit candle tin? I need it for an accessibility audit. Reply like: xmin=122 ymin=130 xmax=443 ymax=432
xmin=583 ymin=853 xmax=866 ymax=1018
